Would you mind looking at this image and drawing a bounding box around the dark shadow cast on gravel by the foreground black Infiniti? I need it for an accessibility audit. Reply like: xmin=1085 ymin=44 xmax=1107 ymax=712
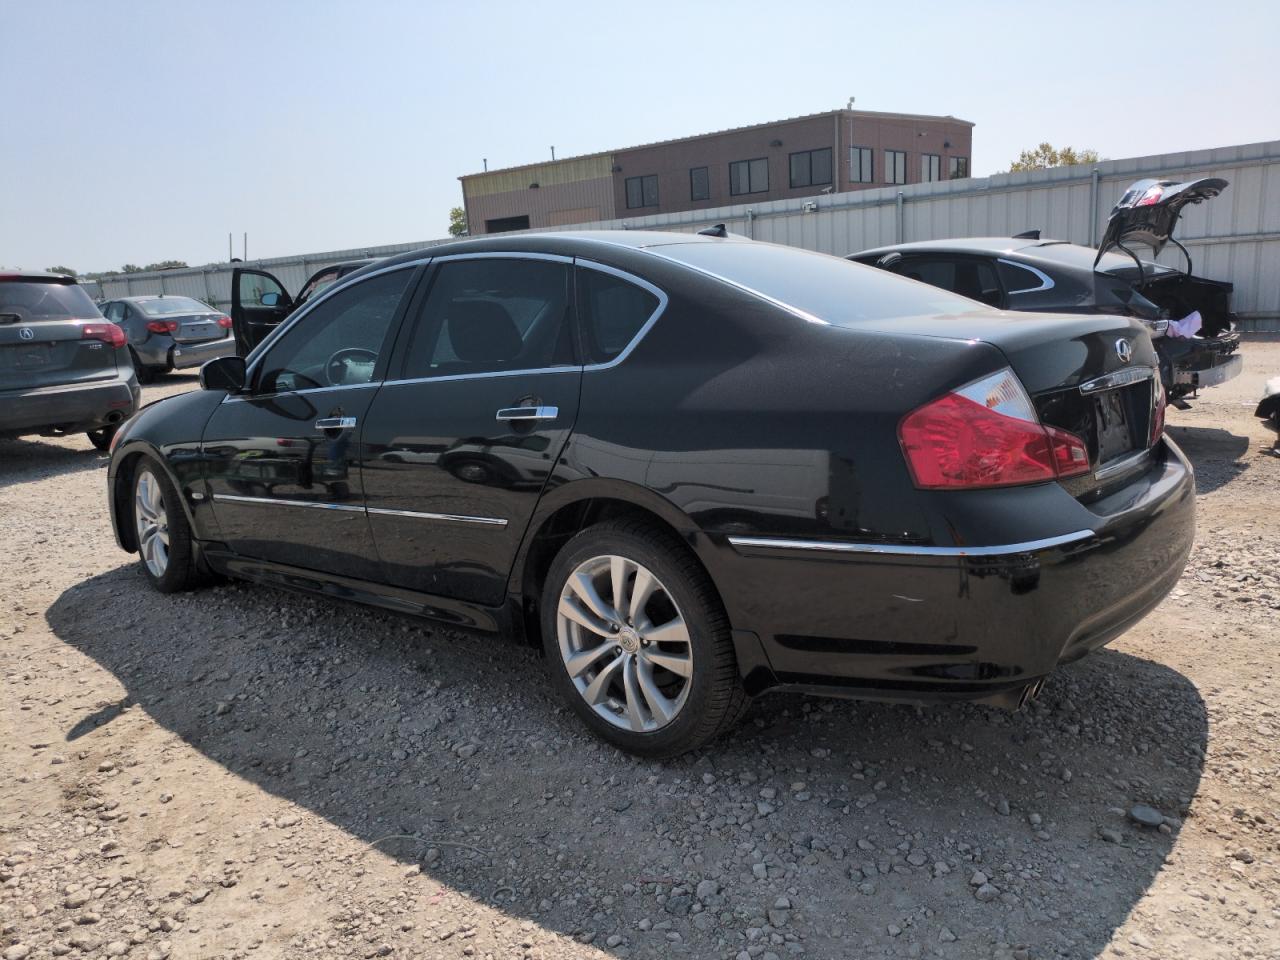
xmin=46 ymin=566 xmax=1207 ymax=957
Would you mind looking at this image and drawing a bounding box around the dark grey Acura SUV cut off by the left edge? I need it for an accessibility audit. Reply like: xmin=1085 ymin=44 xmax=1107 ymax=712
xmin=0 ymin=273 xmax=140 ymax=449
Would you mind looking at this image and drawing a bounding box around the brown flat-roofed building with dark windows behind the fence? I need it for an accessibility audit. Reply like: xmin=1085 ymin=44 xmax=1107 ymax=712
xmin=458 ymin=110 xmax=973 ymax=236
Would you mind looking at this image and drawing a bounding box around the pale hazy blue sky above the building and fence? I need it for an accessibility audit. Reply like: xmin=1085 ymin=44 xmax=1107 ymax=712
xmin=0 ymin=0 xmax=1280 ymax=273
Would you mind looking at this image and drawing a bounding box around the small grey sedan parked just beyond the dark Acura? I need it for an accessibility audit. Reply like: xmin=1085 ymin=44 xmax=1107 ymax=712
xmin=102 ymin=294 xmax=236 ymax=383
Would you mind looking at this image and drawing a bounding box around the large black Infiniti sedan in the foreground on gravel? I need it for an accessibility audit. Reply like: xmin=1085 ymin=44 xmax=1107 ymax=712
xmin=108 ymin=232 xmax=1194 ymax=756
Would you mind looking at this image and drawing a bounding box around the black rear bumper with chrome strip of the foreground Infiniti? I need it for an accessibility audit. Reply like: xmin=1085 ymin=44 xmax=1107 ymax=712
xmin=714 ymin=443 xmax=1196 ymax=705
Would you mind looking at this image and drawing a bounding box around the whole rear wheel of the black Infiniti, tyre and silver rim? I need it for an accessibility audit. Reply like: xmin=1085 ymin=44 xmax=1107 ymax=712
xmin=541 ymin=521 xmax=749 ymax=759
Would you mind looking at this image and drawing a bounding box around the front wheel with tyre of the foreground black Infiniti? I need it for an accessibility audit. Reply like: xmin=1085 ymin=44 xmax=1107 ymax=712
xmin=132 ymin=457 xmax=206 ymax=594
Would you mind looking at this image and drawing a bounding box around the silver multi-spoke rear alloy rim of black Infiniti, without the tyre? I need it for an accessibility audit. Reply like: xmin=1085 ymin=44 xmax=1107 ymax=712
xmin=556 ymin=554 xmax=694 ymax=733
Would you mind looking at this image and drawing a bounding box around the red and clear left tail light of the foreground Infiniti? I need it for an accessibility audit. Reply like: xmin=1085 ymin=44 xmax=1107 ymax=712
xmin=897 ymin=367 xmax=1089 ymax=490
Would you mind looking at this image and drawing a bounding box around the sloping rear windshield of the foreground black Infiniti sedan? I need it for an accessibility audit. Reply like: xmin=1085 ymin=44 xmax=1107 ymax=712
xmin=650 ymin=242 xmax=991 ymax=325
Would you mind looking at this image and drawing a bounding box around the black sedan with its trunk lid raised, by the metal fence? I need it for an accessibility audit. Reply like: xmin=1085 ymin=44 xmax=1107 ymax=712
xmin=849 ymin=178 xmax=1244 ymax=408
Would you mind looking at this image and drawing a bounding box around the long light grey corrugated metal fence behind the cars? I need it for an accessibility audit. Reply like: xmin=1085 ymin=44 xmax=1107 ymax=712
xmin=101 ymin=141 xmax=1280 ymax=330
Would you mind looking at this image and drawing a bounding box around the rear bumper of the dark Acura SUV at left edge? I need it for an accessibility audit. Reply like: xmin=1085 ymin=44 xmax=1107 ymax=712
xmin=0 ymin=367 xmax=141 ymax=436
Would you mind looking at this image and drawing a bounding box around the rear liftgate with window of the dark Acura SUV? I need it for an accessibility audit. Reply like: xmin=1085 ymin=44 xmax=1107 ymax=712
xmin=0 ymin=275 xmax=116 ymax=390
